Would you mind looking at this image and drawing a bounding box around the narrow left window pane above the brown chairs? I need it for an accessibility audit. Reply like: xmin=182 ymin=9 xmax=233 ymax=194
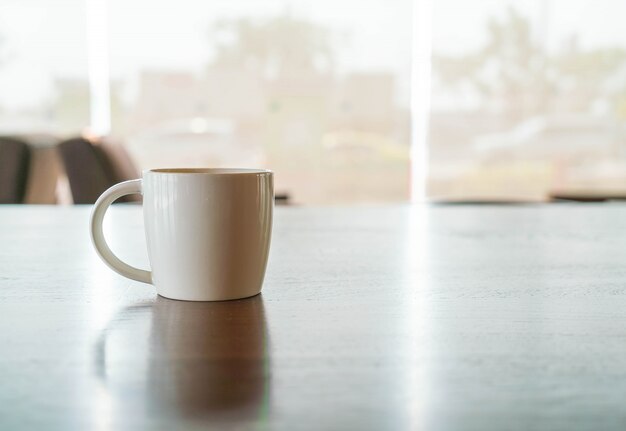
xmin=0 ymin=0 xmax=89 ymax=135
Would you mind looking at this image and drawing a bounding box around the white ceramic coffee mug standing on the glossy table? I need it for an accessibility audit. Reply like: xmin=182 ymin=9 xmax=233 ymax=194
xmin=91 ymin=169 xmax=274 ymax=301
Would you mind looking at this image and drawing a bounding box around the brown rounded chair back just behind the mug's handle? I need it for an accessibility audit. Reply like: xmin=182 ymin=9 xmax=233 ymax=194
xmin=58 ymin=138 xmax=140 ymax=204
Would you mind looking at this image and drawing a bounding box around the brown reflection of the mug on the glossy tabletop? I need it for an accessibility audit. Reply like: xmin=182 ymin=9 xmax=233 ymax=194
xmin=97 ymin=295 xmax=269 ymax=419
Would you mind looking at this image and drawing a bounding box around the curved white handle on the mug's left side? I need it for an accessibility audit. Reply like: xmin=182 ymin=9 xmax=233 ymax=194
xmin=91 ymin=179 xmax=152 ymax=284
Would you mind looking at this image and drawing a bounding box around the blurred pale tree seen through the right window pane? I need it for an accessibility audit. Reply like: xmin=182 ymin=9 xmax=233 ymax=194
xmin=433 ymin=7 xmax=626 ymax=122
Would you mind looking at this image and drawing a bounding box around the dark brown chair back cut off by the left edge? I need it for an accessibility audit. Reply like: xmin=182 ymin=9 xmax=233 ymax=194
xmin=0 ymin=137 xmax=31 ymax=204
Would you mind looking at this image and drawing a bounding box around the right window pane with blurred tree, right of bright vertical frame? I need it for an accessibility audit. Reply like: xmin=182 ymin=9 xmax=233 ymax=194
xmin=428 ymin=0 xmax=626 ymax=200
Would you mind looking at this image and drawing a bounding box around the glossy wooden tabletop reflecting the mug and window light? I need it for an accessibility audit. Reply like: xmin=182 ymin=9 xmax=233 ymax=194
xmin=0 ymin=204 xmax=626 ymax=431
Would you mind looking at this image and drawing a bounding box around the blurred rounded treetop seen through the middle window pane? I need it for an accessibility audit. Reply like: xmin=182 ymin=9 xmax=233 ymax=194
xmin=211 ymin=13 xmax=334 ymax=79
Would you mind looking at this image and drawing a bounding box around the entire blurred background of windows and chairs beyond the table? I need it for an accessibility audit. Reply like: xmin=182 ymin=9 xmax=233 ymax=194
xmin=0 ymin=0 xmax=626 ymax=205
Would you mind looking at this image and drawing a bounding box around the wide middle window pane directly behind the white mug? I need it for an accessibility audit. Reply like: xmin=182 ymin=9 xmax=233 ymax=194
xmin=109 ymin=0 xmax=412 ymax=204
